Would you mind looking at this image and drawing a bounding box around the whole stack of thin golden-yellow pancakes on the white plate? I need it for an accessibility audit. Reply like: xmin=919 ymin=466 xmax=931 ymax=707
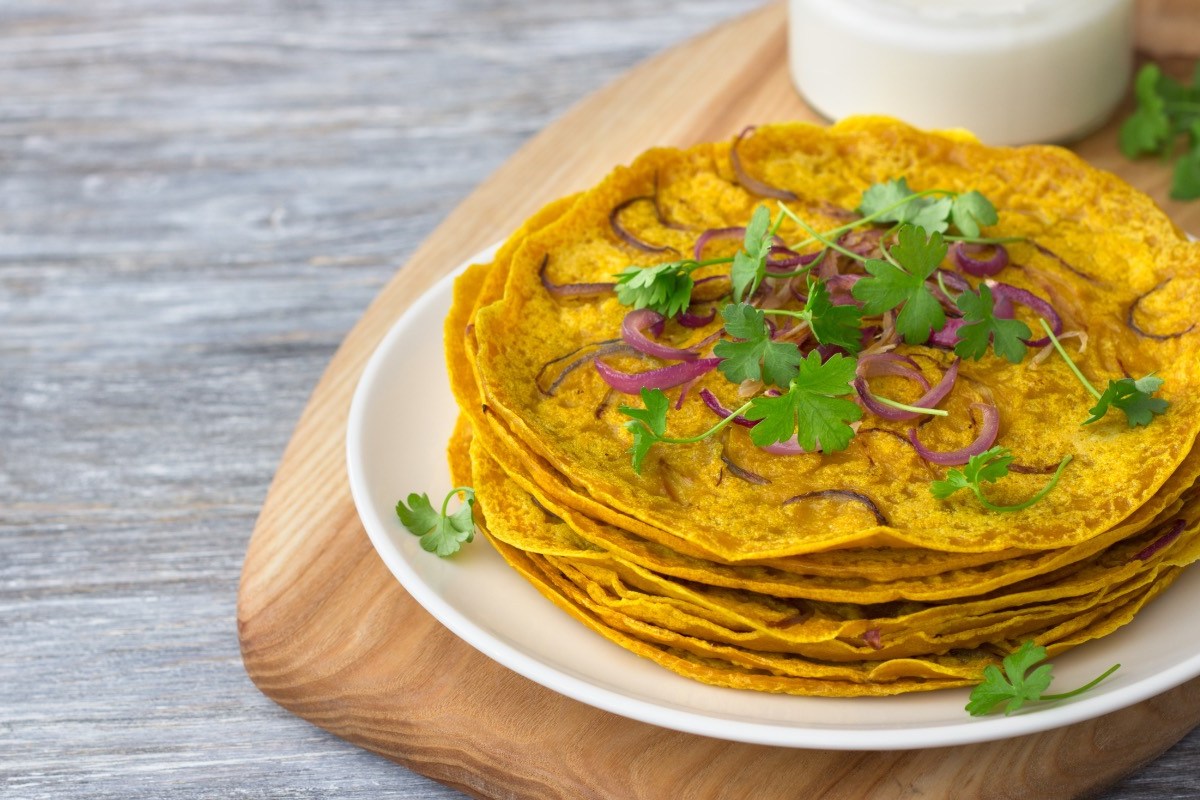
xmin=445 ymin=118 xmax=1200 ymax=696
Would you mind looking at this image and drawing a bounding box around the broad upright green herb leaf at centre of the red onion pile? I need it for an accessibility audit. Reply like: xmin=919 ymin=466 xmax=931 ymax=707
xmin=851 ymin=225 xmax=947 ymax=344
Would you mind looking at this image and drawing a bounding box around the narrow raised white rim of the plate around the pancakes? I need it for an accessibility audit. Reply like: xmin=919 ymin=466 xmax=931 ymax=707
xmin=346 ymin=244 xmax=1200 ymax=751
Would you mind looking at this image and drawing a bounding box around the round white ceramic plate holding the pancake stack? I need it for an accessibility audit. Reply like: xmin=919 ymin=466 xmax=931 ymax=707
xmin=347 ymin=244 xmax=1200 ymax=750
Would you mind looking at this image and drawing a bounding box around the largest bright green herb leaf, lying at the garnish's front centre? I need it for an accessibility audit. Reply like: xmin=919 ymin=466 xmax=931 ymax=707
xmin=745 ymin=350 xmax=863 ymax=453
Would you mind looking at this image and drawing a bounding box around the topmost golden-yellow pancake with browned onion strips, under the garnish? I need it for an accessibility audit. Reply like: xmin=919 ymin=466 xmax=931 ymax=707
xmin=465 ymin=118 xmax=1200 ymax=561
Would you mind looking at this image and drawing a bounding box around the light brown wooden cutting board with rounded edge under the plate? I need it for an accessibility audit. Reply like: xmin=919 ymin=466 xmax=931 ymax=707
xmin=238 ymin=4 xmax=1200 ymax=800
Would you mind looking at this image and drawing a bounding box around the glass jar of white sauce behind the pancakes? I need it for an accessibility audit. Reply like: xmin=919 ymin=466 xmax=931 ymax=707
xmin=788 ymin=0 xmax=1133 ymax=144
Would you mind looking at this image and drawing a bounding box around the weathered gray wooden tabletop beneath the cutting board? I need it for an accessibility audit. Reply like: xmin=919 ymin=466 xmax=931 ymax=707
xmin=0 ymin=0 xmax=1200 ymax=799
